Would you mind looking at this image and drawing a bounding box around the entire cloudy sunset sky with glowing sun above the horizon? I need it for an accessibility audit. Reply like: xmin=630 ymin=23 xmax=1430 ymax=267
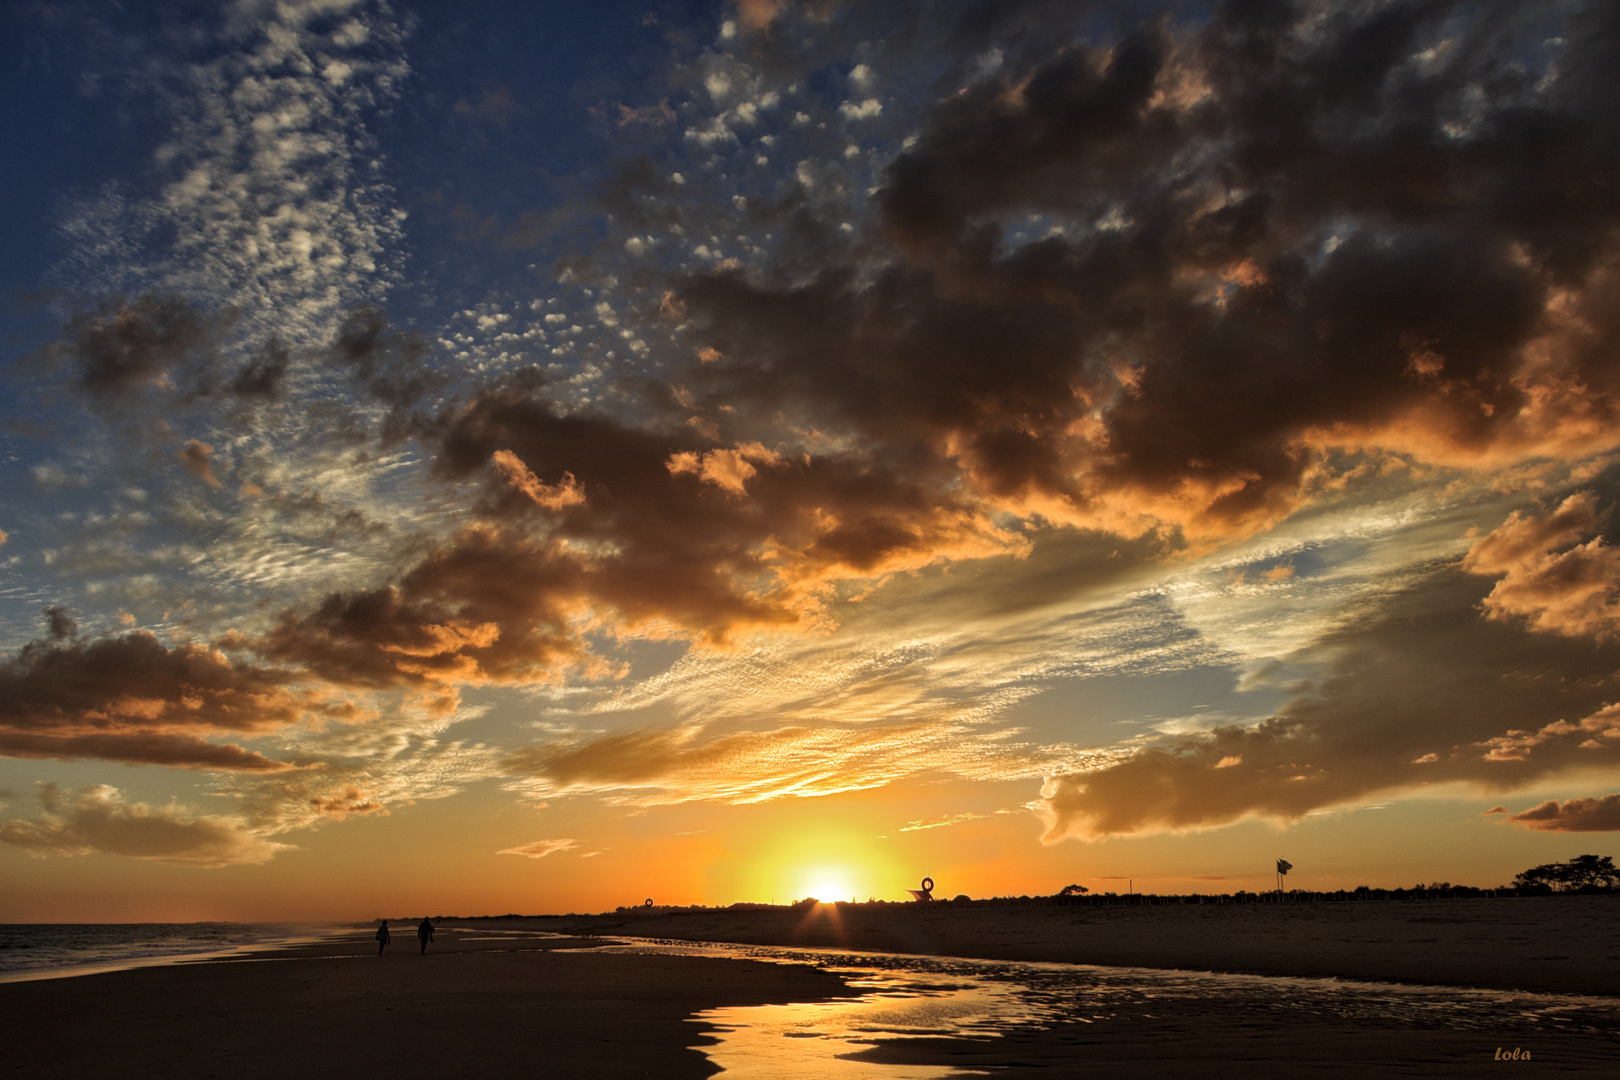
xmin=0 ymin=0 xmax=1620 ymax=921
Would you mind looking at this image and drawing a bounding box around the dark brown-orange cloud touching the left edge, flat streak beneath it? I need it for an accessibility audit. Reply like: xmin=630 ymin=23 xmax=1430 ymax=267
xmin=0 ymin=609 xmax=302 ymax=772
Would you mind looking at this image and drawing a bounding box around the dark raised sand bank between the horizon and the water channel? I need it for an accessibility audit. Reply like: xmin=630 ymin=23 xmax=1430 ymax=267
xmin=479 ymin=895 xmax=1620 ymax=996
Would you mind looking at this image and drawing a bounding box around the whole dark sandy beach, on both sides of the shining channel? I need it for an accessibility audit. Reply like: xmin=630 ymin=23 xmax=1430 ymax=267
xmin=0 ymin=897 xmax=1620 ymax=1080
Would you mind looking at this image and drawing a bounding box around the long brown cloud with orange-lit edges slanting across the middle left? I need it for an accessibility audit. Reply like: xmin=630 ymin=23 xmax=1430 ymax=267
xmin=254 ymin=387 xmax=1029 ymax=709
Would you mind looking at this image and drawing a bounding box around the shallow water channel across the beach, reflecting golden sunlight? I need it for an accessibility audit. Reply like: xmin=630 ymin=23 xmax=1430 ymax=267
xmin=576 ymin=939 xmax=1620 ymax=1080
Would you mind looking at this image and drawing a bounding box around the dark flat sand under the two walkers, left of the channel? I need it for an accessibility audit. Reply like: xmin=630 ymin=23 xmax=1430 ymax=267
xmin=0 ymin=928 xmax=847 ymax=1080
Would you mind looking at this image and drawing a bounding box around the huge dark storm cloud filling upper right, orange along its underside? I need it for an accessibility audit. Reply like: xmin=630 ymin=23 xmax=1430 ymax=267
xmin=679 ymin=3 xmax=1620 ymax=539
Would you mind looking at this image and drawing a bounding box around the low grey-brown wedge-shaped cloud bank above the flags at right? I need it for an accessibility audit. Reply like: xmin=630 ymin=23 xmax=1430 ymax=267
xmin=1045 ymin=568 xmax=1620 ymax=839
